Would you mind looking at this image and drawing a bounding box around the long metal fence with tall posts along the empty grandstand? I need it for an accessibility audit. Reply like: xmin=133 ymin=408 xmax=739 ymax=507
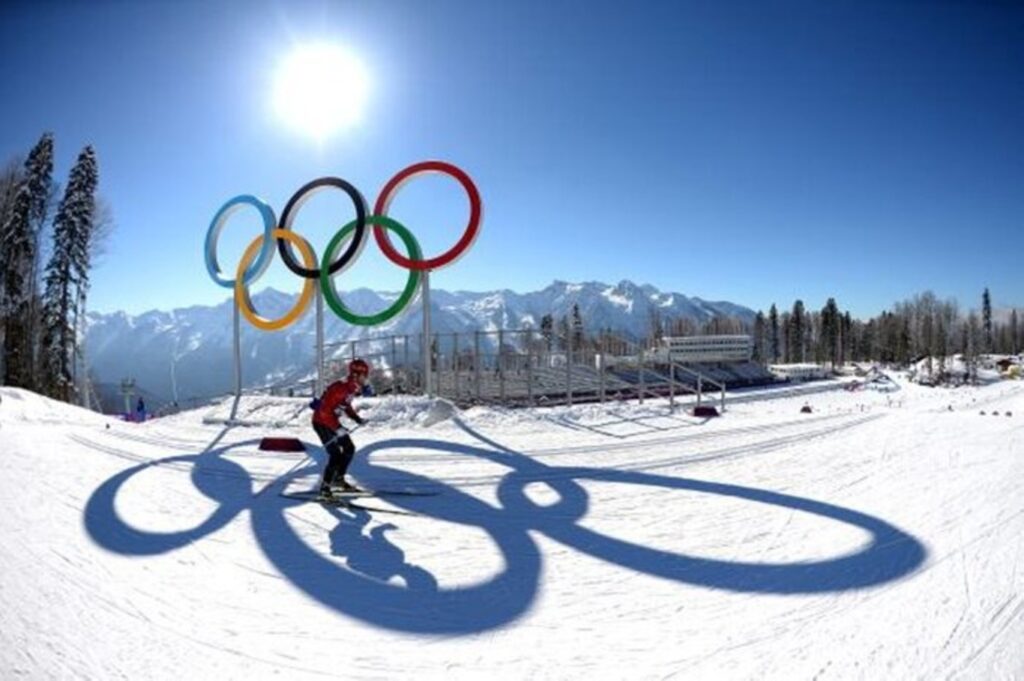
xmin=325 ymin=329 xmax=725 ymax=411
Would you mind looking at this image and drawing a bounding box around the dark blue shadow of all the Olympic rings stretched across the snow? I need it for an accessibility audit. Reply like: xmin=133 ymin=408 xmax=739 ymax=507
xmin=84 ymin=422 xmax=927 ymax=635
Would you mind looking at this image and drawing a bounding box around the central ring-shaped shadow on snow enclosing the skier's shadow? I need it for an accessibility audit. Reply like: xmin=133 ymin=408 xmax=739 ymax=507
xmin=251 ymin=443 xmax=541 ymax=634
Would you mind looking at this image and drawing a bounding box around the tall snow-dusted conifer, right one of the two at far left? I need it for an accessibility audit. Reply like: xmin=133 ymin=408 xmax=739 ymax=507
xmin=42 ymin=146 xmax=98 ymax=400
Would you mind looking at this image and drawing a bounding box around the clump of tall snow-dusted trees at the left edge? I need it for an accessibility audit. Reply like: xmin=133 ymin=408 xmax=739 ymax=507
xmin=0 ymin=133 xmax=113 ymax=401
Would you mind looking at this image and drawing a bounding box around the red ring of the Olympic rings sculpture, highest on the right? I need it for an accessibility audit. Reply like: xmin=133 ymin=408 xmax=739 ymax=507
xmin=374 ymin=161 xmax=483 ymax=271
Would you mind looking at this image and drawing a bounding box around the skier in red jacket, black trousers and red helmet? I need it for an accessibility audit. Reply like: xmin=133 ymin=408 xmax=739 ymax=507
xmin=312 ymin=359 xmax=370 ymax=498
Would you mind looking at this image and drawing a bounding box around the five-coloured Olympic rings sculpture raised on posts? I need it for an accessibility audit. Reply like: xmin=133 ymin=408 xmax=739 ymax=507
xmin=205 ymin=161 xmax=483 ymax=331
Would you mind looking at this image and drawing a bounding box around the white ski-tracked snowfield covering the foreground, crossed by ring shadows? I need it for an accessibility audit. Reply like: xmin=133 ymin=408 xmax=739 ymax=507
xmin=0 ymin=374 xmax=1024 ymax=680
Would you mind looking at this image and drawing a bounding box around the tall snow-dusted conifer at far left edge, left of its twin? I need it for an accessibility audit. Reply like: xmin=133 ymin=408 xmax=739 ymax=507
xmin=0 ymin=132 xmax=53 ymax=389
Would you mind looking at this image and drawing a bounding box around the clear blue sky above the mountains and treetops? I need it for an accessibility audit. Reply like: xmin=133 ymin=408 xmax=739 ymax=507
xmin=0 ymin=0 xmax=1024 ymax=316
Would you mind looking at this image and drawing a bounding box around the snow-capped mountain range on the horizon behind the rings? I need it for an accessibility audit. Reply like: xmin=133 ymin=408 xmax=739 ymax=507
xmin=85 ymin=281 xmax=754 ymax=401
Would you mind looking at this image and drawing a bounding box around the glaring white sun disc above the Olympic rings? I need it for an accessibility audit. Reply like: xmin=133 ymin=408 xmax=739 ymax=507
xmin=273 ymin=43 xmax=369 ymax=140
